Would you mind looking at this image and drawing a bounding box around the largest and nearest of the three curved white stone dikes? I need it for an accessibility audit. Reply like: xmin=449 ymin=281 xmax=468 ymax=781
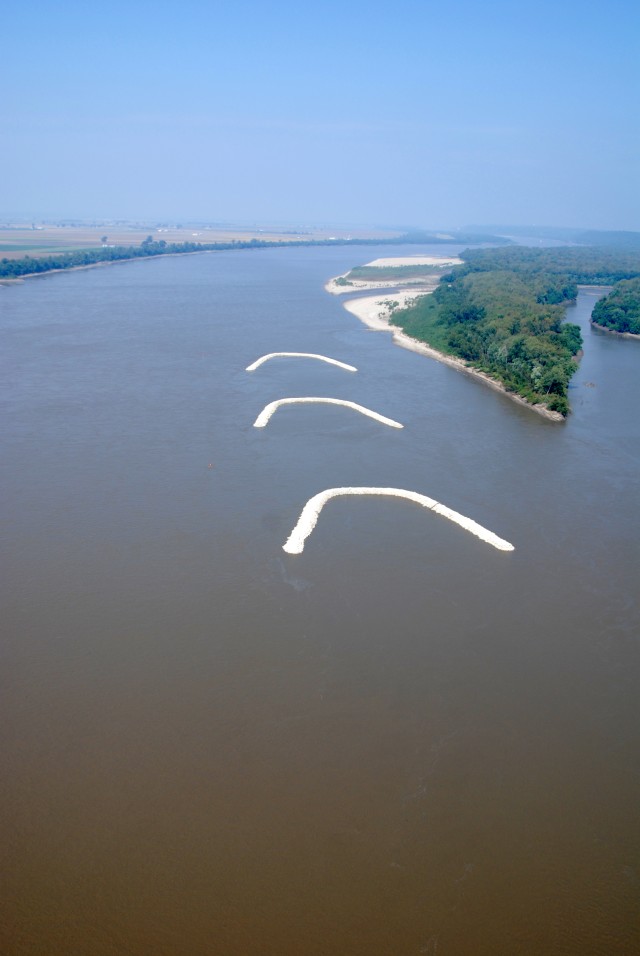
xmin=282 ymin=487 xmax=515 ymax=554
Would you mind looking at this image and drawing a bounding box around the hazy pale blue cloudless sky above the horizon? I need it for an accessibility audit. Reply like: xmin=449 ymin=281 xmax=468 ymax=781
xmin=0 ymin=0 xmax=640 ymax=229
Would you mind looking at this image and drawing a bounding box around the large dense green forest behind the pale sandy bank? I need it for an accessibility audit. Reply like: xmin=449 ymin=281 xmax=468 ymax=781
xmin=391 ymin=246 xmax=640 ymax=415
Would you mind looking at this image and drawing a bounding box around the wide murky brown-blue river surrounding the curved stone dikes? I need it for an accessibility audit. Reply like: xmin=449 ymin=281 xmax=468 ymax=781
xmin=0 ymin=246 xmax=640 ymax=956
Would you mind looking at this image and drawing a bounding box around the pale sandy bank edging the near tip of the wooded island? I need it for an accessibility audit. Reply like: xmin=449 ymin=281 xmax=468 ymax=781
xmin=338 ymin=280 xmax=565 ymax=422
